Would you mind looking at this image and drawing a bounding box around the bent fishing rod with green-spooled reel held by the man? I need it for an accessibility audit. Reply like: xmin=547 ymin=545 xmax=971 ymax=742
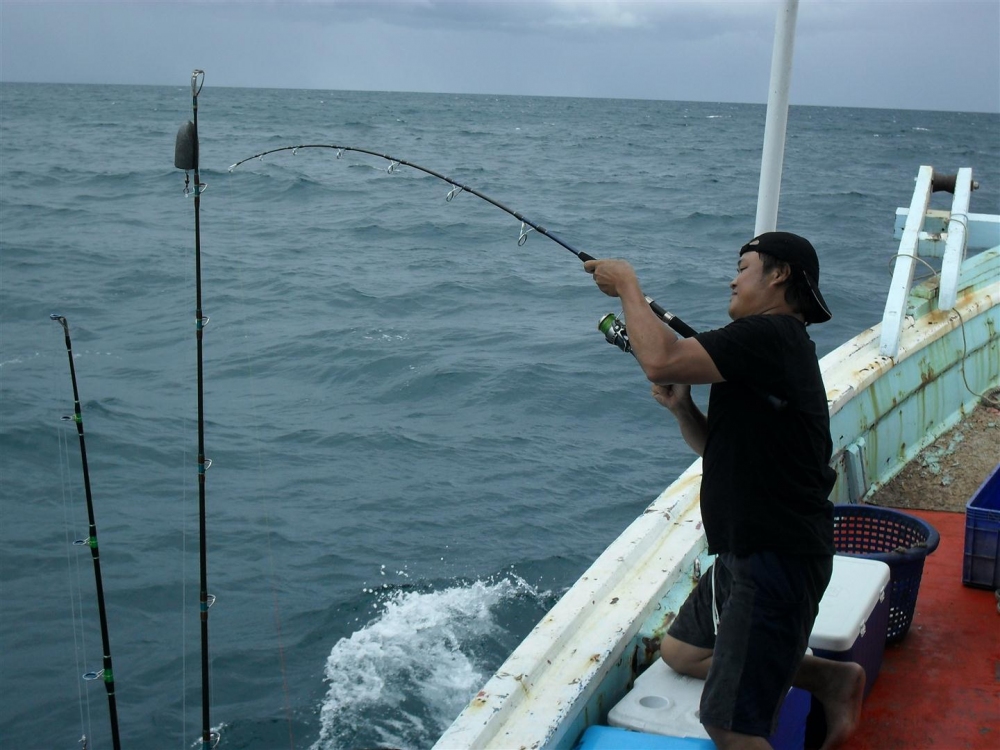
xmin=229 ymin=143 xmax=696 ymax=342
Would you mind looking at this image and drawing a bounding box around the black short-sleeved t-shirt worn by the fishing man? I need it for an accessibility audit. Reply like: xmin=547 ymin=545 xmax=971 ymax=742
xmin=697 ymin=315 xmax=836 ymax=555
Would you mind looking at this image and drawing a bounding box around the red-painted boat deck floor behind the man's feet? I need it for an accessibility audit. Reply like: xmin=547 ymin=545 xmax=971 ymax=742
xmin=844 ymin=510 xmax=1000 ymax=750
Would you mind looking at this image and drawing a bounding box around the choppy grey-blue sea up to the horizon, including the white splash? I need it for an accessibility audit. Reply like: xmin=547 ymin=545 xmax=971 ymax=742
xmin=0 ymin=82 xmax=1000 ymax=750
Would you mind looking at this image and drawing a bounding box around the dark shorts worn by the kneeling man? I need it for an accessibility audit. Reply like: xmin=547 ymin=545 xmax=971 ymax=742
xmin=667 ymin=552 xmax=833 ymax=737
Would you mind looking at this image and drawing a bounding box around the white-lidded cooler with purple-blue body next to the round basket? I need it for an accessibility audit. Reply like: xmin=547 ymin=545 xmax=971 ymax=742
xmin=809 ymin=555 xmax=889 ymax=696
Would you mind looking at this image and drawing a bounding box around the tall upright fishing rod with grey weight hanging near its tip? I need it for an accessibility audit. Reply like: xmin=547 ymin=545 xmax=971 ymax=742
xmin=174 ymin=69 xmax=219 ymax=750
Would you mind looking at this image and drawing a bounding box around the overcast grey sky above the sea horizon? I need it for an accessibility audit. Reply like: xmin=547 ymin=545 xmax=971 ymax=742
xmin=0 ymin=0 xmax=1000 ymax=112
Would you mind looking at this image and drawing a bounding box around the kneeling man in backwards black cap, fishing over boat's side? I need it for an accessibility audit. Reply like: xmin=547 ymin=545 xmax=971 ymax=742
xmin=584 ymin=232 xmax=865 ymax=750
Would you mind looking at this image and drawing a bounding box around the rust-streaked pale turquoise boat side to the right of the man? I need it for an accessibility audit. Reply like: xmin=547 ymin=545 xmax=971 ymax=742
xmin=823 ymin=248 xmax=1000 ymax=503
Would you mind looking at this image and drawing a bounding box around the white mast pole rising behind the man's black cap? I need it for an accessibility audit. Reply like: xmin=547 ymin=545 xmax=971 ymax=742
xmin=754 ymin=0 xmax=799 ymax=236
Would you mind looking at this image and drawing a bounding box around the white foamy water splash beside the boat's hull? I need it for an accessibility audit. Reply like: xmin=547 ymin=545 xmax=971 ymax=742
xmin=311 ymin=577 xmax=537 ymax=750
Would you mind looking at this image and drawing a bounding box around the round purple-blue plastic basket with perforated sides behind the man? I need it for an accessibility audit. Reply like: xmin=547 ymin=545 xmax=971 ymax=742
xmin=833 ymin=505 xmax=941 ymax=644
